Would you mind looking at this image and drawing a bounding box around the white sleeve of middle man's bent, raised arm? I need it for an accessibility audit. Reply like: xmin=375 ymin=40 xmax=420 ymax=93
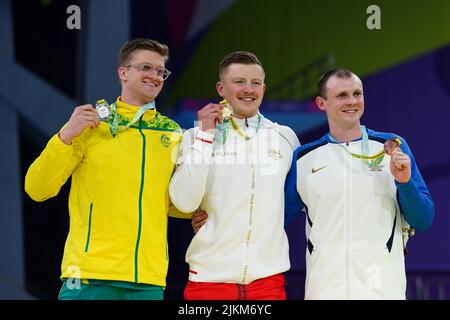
xmin=169 ymin=129 xmax=213 ymax=213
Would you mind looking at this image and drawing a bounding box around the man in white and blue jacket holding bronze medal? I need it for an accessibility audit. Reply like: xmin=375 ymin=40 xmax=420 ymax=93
xmin=285 ymin=69 xmax=434 ymax=299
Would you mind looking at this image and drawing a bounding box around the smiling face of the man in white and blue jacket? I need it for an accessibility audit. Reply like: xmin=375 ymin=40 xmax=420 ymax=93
xmin=316 ymin=75 xmax=364 ymax=132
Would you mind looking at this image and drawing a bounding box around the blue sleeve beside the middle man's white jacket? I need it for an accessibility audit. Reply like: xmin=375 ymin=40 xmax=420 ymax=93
xmin=284 ymin=148 xmax=305 ymax=228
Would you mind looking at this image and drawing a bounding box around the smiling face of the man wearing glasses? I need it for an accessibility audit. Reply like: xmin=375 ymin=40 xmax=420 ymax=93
xmin=118 ymin=50 xmax=165 ymax=106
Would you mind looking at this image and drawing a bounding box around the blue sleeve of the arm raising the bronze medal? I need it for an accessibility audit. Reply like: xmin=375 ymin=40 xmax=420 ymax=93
xmin=395 ymin=139 xmax=434 ymax=231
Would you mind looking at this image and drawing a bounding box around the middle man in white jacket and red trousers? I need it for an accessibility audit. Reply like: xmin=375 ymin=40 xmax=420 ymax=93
xmin=169 ymin=51 xmax=300 ymax=300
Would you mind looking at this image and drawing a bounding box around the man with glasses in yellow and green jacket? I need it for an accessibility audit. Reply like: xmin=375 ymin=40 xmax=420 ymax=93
xmin=25 ymin=39 xmax=182 ymax=299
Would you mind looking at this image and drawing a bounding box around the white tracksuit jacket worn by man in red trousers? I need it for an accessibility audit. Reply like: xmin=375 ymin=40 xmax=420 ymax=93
xmin=169 ymin=114 xmax=300 ymax=284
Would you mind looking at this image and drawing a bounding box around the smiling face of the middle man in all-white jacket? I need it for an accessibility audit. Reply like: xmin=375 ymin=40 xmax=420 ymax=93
xmin=216 ymin=63 xmax=266 ymax=119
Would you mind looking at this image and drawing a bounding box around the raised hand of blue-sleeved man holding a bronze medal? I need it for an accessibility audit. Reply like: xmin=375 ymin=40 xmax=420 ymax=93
xmin=384 ymin=138 xmax=411 ymax=183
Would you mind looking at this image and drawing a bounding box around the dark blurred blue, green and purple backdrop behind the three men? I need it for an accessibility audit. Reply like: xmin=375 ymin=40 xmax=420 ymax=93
xmin=0 ymin=0 xmax=450 ymax=299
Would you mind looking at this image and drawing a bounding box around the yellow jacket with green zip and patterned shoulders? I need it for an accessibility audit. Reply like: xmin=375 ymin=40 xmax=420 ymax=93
xmin=25 ymin=97 xmax=182 ymax=286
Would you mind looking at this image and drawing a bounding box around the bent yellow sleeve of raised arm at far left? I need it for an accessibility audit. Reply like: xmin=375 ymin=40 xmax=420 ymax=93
xmin=25 ymin=130 xmax=86 ymax=202
